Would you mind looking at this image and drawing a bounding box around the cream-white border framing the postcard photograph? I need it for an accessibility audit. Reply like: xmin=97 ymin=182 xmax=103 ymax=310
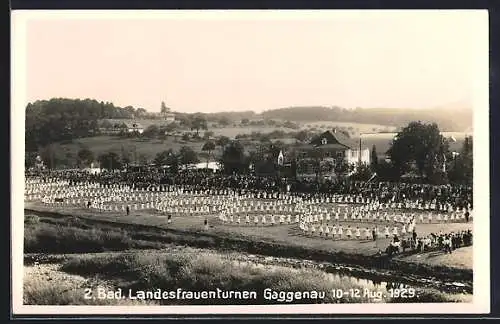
xmin=11 ymin=10 xmax=490 ymax=315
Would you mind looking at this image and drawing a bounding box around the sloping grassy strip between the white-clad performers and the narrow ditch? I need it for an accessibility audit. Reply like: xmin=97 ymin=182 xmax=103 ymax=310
xmin=25 ymin=210 xmax=473 ymax=284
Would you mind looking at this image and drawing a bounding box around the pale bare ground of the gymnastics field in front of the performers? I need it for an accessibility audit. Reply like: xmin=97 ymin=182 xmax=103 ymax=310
xmin=25 ymin=203 xmax=472 ymax=271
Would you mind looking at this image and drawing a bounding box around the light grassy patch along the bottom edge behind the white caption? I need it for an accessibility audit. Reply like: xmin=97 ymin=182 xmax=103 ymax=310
xmin=24 ymin=248 xmax=467 ymax=305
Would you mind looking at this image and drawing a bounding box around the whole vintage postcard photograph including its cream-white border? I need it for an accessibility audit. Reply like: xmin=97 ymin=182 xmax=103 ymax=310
xmin=11 ymin=10 xmax=490 ymax=314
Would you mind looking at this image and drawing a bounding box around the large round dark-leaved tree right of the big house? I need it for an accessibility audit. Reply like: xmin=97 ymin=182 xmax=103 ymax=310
xmin=387 ymin=122 xmax=448 ymax=178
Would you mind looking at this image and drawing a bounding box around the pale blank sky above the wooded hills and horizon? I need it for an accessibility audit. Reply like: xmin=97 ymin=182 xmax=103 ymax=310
xmin=13 ymin=10 xmax=488 ymax=112
